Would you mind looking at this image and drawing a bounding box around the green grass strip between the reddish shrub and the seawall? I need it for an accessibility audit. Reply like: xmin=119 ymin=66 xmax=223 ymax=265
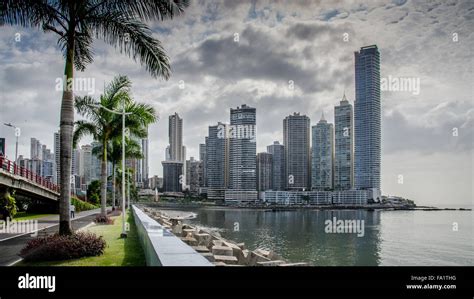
xmin=17 ymin=212 xmax=146 ymax=266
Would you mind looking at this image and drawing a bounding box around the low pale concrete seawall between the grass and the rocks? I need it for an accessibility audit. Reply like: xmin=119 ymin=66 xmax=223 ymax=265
xmin=132 ymin=205 xmax=214 ymax=267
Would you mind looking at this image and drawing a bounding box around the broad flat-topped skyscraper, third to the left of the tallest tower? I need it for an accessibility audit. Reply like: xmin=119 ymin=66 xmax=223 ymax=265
xmin=283 ymin=112 xmax=311 ymax=190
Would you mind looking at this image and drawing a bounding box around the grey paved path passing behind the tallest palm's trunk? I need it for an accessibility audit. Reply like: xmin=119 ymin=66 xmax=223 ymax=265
xmin=0 ymin=209 xmax=108 ymax=266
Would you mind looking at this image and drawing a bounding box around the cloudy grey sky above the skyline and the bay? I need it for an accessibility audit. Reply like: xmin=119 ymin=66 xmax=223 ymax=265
xmin=0 ymin=0 xmax=474 ymax=205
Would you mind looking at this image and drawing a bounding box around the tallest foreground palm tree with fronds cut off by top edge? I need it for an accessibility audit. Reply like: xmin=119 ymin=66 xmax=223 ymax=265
xmin=0 ymin=0 xmax=189 ymax=235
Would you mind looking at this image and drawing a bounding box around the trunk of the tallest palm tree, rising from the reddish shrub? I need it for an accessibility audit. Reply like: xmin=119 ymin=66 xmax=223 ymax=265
xmin=59 ymin=37 xmax=74 ymax=235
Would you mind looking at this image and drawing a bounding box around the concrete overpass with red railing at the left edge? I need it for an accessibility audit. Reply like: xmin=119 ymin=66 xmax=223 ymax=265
xmin=0 ymin=157 xmax=59 ymax=201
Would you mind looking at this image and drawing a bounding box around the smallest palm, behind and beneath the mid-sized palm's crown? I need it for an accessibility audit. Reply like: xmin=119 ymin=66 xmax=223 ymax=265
xmin=92 ymin=138 xmax=143 ymax=209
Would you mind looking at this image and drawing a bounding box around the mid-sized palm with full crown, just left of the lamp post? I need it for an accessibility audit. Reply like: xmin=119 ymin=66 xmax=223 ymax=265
xmin=73 ymin=76 xmax=157 ymax=216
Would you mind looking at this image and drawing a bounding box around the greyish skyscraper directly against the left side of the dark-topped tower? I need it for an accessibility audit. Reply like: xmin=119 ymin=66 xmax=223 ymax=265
xmin=206 ymin=122 xmax=229 ymax=199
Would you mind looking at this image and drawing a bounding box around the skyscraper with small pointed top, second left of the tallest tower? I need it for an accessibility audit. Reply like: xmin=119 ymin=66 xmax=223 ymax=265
xmin=311 ymin=113 xmax=334 ymax=190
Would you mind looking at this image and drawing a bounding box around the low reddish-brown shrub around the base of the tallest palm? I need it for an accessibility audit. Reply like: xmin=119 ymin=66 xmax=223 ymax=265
xmin=20 ymin=232 xmax=106 ymax=261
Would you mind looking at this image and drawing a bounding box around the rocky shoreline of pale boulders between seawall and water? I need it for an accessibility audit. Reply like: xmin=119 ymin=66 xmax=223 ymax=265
xmin=142 ymin=207 xmax=308 ymax=266
